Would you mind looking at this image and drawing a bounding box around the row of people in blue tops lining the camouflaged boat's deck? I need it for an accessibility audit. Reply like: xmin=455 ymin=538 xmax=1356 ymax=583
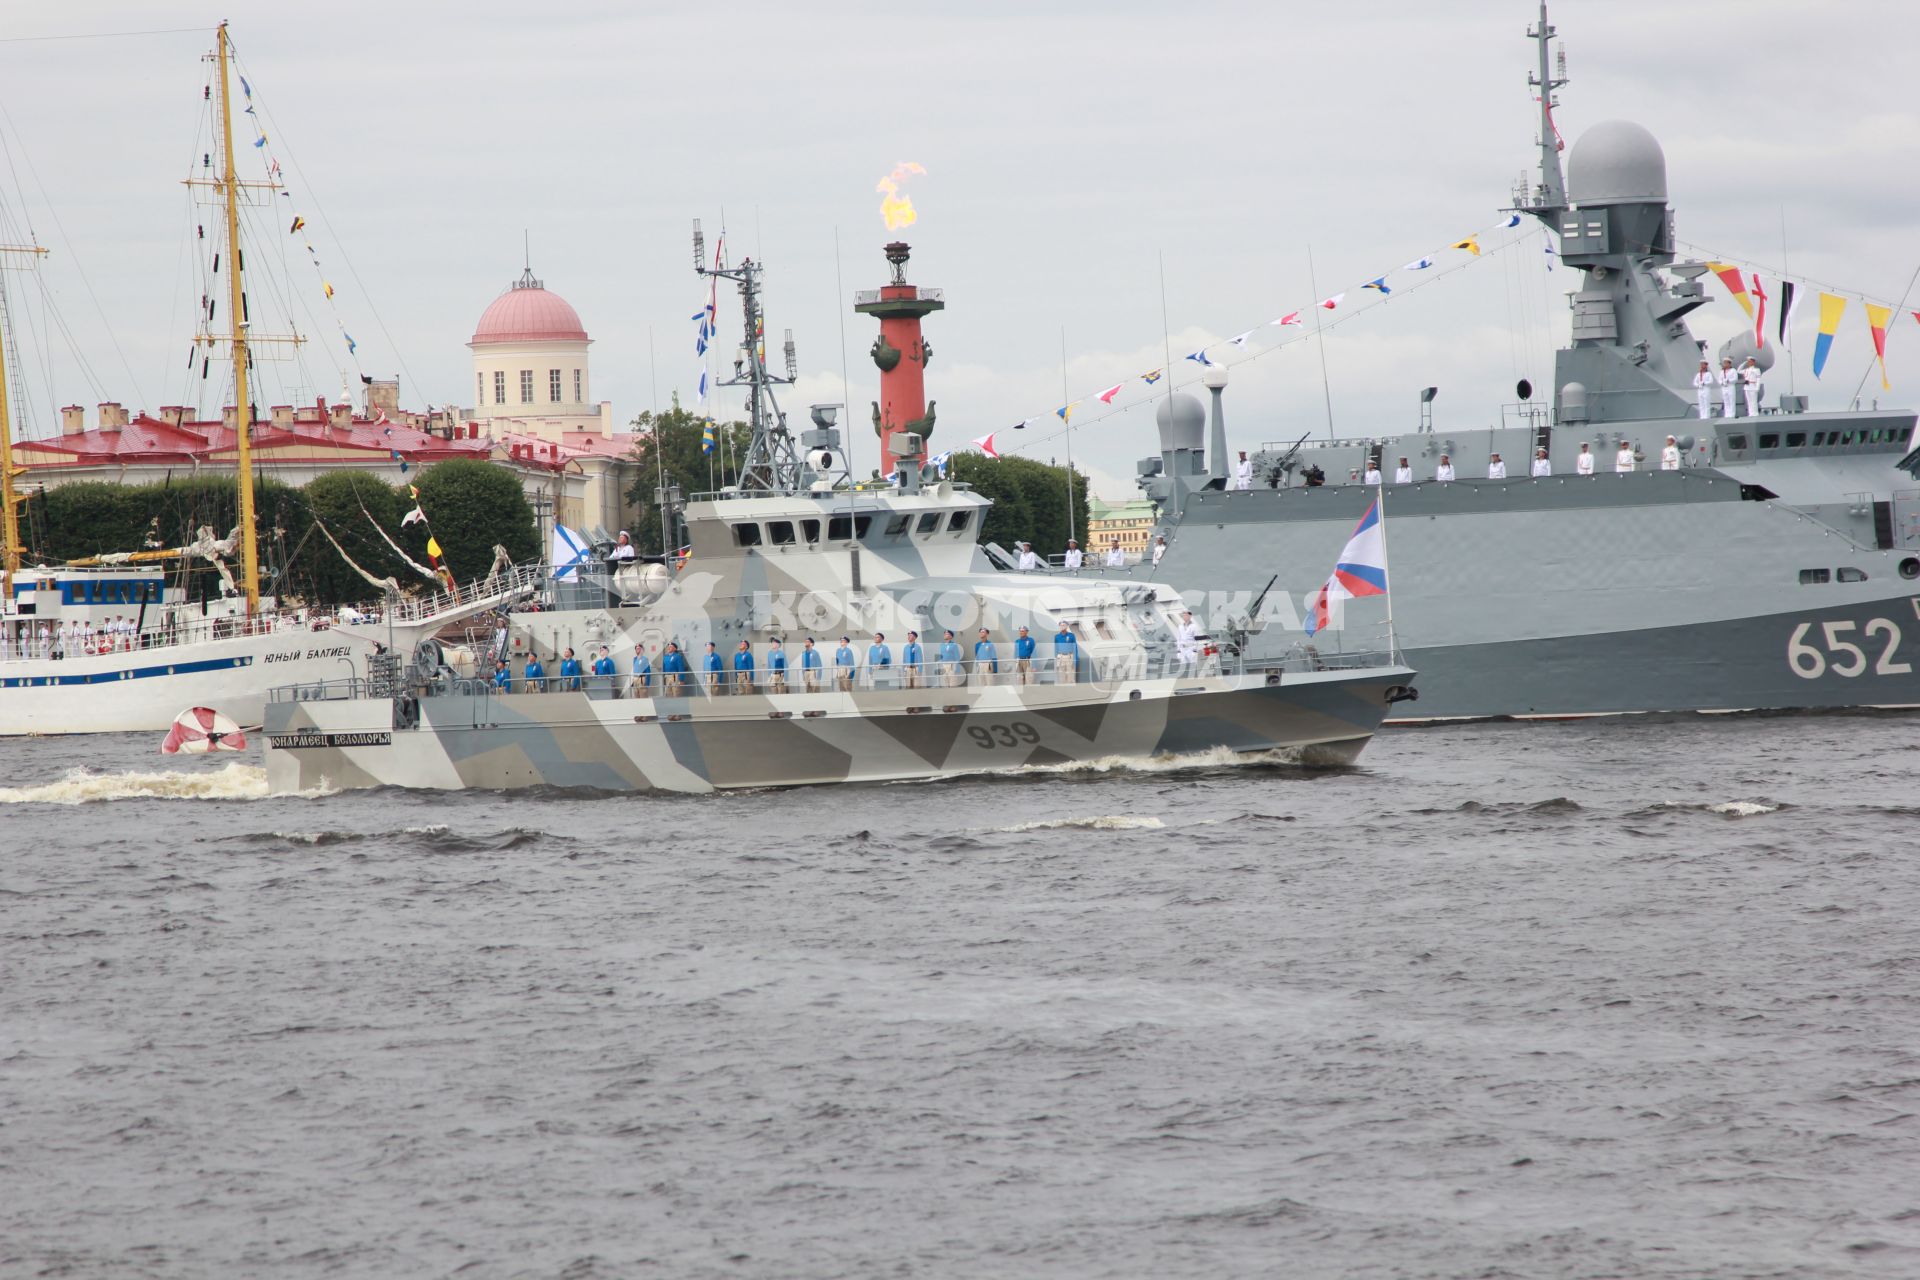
xmin=490 ymin=622 xmax=1081 ymax=699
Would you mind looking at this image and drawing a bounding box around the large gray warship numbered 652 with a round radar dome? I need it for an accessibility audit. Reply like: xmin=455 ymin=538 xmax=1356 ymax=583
xmin=1131 ymin=4 xmax=1920 ymax=722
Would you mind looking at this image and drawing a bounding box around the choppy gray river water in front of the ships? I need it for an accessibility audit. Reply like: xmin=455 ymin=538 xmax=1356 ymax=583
xmin=0 ymin=714 xmax=1920 ymax=1278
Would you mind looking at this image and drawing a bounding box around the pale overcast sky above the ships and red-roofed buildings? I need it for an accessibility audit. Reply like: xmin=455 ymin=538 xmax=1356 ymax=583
xmin=0 ymin=0 xmax=1920 ymax=499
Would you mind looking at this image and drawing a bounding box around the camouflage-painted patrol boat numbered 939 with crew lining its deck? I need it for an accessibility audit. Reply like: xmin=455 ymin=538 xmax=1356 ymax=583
xmin=263 ymin=246 xmax=1413 ymax=793
